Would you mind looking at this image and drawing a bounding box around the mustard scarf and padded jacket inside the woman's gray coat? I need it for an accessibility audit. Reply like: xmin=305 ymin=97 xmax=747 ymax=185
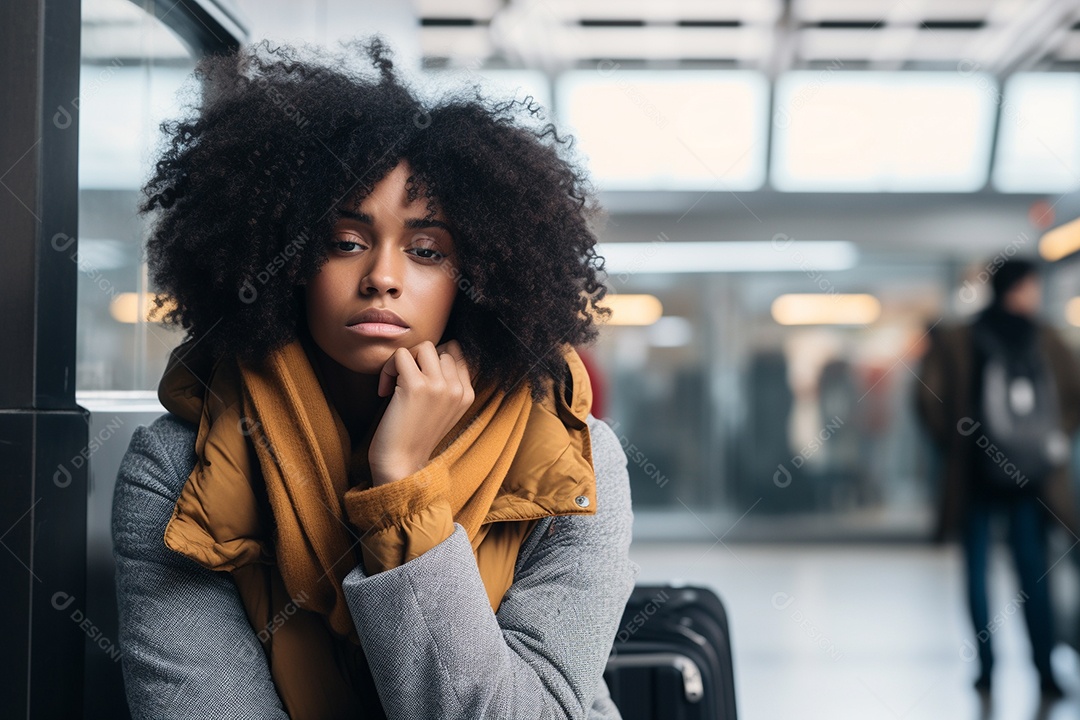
xmin=159 ymin=340 xmax=596 ymax=642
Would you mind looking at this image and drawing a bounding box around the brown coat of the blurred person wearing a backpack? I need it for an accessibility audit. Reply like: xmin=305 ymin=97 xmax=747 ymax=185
xmin=916 ymin=325 xmax=1080 ymax=540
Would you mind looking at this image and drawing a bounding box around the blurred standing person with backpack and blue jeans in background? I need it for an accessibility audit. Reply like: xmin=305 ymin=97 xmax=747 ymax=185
xmin=917 ymin=259 xmax=1080 ymax=697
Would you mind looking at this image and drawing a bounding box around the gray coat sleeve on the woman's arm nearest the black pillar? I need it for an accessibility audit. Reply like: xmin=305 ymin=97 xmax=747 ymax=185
xmin=112 ymin=417 xmax=287 ymax=720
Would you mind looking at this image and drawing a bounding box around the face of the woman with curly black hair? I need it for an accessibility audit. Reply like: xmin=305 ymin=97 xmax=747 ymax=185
xmin=305 ymin=161 xmax=458 ymax=375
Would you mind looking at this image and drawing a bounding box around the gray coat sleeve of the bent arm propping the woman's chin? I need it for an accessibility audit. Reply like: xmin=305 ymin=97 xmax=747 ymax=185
xmin=343 ymin=417 xmax=638 ymax=720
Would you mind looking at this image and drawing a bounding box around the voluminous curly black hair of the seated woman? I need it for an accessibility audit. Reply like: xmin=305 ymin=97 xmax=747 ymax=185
xmin=140 ymin=38 xmax=610 ymax=400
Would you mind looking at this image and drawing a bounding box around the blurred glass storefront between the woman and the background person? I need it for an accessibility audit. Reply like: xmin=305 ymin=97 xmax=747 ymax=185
xmin=593 ymin=259 xmax=953 ymax=539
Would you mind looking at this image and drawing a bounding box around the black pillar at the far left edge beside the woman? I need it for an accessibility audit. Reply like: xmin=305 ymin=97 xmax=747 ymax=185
xmin=0 ymin=0 xmax=93 ymax=718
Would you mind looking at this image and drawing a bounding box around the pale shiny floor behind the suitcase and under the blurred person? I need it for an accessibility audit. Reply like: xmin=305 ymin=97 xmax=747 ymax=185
xmin=631 ymin=543 xmax=1080 ymax=720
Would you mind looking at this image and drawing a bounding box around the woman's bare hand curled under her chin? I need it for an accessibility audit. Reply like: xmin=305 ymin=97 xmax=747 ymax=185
xmin=367 ymin=340 xmax=475 ymax=486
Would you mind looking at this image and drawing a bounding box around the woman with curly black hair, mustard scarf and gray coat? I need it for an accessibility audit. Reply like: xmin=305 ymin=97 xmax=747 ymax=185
xmin=113 ymin=41 xmax=637 ymax=718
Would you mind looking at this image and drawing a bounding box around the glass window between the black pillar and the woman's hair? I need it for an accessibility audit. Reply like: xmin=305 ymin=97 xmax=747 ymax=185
xmin=77 ymin=0 xmax=194 ymax=391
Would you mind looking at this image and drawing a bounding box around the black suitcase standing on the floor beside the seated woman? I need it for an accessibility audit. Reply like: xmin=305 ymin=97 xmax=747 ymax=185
xmin=604 ymin=585 xmax=735 ymax=720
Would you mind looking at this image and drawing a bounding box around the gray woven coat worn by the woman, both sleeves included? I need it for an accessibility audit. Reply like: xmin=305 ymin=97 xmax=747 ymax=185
xmin=112 ymin=415 xmax=638 ymax=720
